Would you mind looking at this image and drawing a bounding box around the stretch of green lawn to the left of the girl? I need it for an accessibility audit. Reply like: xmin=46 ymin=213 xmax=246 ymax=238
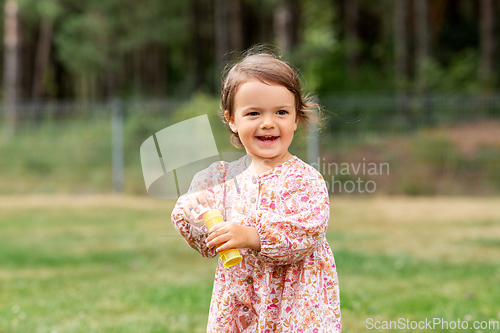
xmin=0 ymin=199 xmax=216 ymax=332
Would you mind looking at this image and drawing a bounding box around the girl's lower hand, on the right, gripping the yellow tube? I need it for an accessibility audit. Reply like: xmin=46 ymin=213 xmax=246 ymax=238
xmin=206 ymin=222 xmax=260 ymax=252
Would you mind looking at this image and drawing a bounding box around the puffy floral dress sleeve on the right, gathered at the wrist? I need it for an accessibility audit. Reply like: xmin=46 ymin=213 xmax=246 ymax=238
xmin=247 ymin=171 xmax=330 ymax=265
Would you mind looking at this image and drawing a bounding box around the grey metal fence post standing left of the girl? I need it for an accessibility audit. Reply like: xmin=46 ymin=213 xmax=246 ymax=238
xmin=111 ymin=98 xmax=125 ymax=193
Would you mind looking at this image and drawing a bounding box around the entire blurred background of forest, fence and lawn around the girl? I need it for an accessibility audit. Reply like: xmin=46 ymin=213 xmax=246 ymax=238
xmin=0 ymin=0 xmax=500 ymax=333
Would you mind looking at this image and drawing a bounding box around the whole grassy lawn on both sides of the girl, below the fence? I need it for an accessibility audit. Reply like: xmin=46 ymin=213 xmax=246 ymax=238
xmin=0 ymin=195 xmax=500 ymax=333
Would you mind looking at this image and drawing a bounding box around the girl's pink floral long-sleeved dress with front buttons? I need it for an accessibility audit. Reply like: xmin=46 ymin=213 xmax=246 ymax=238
xmin=172 ymin=155 xmax=341 ymax=333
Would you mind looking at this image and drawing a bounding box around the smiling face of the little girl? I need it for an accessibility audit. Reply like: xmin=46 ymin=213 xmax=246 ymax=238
xmin=225 ymin=79 xmax=298 ymax=170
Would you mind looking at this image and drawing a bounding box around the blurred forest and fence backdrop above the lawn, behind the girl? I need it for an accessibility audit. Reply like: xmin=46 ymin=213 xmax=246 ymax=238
xmin=0 ymin=0 xmax=500 ymax=195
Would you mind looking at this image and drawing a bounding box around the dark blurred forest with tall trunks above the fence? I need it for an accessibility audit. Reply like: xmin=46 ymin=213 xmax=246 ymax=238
xmin=1 ymin=0 xmax=500 ymax=100
